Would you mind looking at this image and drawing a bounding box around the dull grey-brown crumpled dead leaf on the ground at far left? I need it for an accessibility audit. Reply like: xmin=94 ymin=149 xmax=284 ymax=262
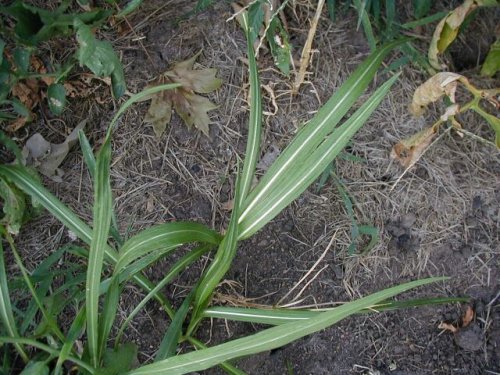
xmin=23 ymin=121 xmax=86 ymax=181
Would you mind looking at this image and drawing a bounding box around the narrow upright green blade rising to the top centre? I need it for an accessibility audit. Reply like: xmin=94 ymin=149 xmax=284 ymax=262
xmin=239 ymin=12 xmax=262 ymax=207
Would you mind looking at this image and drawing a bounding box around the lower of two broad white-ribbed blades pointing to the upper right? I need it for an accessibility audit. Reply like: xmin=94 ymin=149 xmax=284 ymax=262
xmin=239 ymin=76 xmax=397 ymax=239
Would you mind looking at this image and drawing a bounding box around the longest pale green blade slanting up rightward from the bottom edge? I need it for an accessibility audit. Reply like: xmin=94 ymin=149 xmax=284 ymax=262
xmin=128 ymin=277 xmax=446 ymax=375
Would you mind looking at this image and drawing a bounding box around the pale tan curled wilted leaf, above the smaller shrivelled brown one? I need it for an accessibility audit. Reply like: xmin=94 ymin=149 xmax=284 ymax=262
xmin=410 ymin=72 xmax=466 ymax=116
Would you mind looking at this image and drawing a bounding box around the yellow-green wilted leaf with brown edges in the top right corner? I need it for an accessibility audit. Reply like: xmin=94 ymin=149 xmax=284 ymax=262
xmin=428 ymin=0 xmax=478 ymax=70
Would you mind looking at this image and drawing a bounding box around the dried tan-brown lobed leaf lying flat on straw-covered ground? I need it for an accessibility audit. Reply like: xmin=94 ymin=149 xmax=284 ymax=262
xmin=144 ymin=51 xmax=222 ymax=138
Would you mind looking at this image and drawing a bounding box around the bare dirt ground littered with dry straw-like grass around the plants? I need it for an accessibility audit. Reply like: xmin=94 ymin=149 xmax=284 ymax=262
xmin=8 ymin=1 xmax=500 ymax=375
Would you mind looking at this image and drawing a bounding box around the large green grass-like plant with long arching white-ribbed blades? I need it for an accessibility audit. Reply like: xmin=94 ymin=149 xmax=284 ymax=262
xmin=0 ymin=10 xmax=456 ymax=375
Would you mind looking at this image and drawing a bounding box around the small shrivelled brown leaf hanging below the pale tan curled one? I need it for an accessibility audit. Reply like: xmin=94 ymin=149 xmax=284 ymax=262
xmin=391 ymin=127 xmax=436 ymax=168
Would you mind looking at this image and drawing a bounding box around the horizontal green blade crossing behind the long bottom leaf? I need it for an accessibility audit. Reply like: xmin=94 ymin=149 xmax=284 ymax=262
xmin=203 ymin=297 xmax=470 ymax=325
